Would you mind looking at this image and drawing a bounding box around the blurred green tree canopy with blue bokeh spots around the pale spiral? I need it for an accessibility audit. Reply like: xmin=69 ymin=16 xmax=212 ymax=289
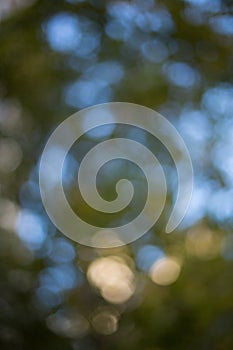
xmin=0 ymin=0 xmax=233 ymax=350
